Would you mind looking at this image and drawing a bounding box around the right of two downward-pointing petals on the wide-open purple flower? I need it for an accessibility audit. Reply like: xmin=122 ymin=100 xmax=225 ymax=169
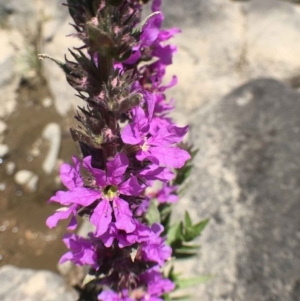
xmin=113 ymin=198 xmax=136 ymax=233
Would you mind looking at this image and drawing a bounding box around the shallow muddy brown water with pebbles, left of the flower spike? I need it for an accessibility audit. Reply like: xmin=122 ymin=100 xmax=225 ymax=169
xmin=0 ymin=79 xmax=79 ymax=271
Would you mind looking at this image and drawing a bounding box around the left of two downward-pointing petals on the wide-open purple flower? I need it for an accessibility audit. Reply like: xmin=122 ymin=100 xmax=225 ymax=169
xmin=90 ymin=200 xmax=112 ymax=236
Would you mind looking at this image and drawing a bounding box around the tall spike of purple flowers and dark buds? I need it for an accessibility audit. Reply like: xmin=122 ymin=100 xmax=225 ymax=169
xmin=47 ymin=0 xmax=190 ymax=301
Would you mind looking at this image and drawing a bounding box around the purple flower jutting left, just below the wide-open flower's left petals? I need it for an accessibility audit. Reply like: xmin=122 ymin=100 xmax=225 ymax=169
xmin=59 ymin=234 xmax=98 ymax=268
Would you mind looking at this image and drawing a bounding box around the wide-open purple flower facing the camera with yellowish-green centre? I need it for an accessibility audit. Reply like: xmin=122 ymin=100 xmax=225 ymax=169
xmin=47 ymin=153 xmax=143 ymax=236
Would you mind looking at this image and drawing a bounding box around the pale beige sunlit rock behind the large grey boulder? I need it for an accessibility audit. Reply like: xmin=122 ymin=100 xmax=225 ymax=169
xmin=162 ymin=0 xmax=300 ymax=115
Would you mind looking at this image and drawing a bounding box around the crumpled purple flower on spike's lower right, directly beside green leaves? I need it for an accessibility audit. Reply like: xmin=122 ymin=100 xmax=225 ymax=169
xmin=142 ymin=223 xmax=172 ymax=266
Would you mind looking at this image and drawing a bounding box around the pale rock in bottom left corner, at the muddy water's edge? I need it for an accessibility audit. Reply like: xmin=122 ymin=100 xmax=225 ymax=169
xmin=0 ymin=265 xmax=76 ymax=301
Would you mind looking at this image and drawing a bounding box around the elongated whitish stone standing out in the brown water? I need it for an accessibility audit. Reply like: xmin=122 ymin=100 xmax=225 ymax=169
xmin=42 ymin=123 xmax=61 ymax=174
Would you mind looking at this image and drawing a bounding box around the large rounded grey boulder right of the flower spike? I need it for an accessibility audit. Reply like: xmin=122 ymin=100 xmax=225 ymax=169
xmin=183 ymin=79 xmax=300 ymax=301
